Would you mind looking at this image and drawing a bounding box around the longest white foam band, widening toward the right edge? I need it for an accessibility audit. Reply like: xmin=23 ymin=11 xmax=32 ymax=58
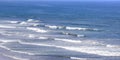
xmin=16 ymin=42 xmax=120 ymax=56
